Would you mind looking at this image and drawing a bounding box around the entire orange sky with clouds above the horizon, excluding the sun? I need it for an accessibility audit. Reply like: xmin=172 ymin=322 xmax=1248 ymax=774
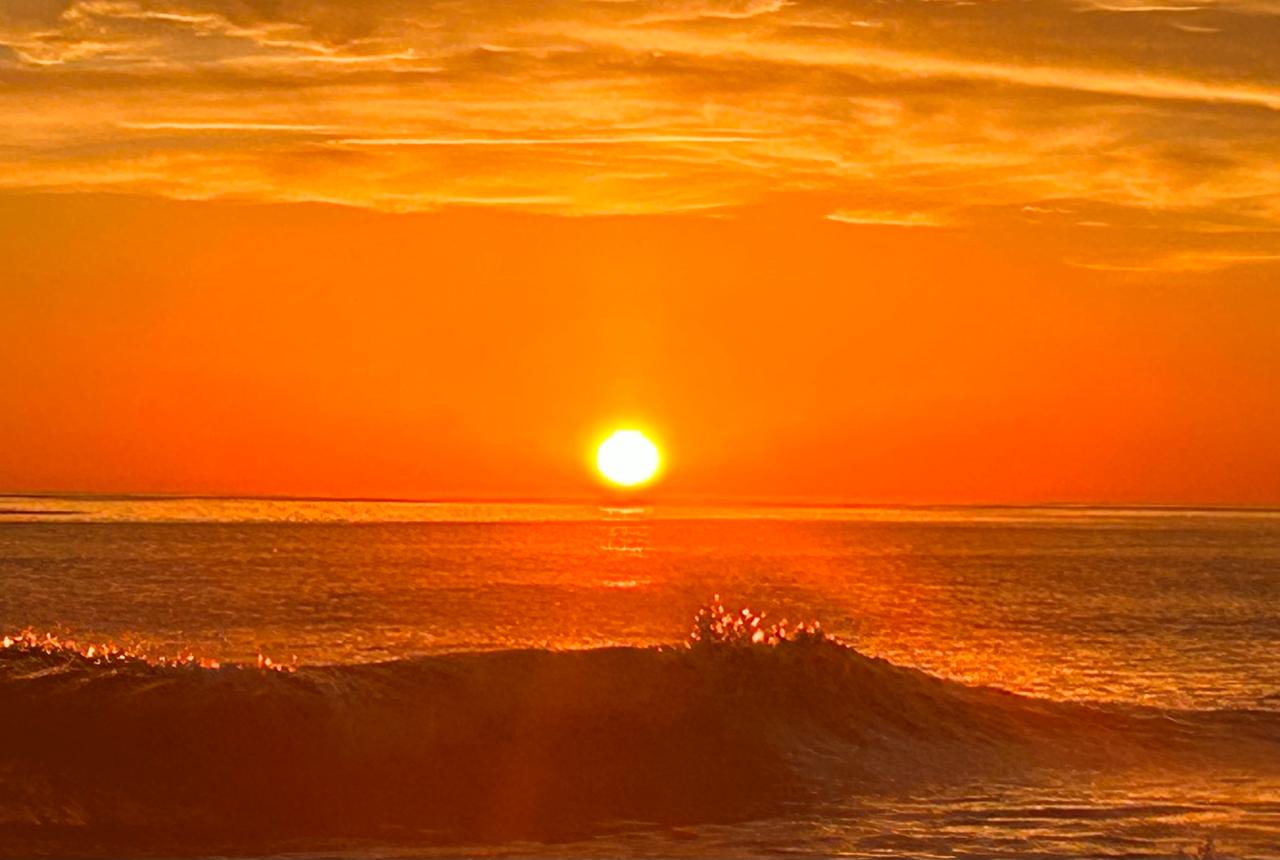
xmin=0 ymin=0 xmax=1280 ymax=503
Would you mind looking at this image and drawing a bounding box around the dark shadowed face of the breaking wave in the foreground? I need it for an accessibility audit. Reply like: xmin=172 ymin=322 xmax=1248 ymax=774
xmin=0 ymin=637 xmax=1280 ymax=856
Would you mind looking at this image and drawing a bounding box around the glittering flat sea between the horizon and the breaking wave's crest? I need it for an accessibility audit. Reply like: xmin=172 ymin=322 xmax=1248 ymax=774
xmin=0 ymin=497 xmax=1280 ymax=706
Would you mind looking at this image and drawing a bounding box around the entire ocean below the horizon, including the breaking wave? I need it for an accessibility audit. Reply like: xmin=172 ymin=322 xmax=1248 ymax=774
xmin=0 ymin=497 xmax=1280 ymax=857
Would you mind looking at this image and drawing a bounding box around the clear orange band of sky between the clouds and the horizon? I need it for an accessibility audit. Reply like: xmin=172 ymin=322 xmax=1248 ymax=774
xmin=0 ymin=193 xmax=1280 ymax=503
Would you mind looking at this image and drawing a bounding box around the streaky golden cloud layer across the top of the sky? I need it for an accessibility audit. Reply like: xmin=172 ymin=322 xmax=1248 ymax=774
xmin=0 ymin=0 xmax=1280 ymax=271
